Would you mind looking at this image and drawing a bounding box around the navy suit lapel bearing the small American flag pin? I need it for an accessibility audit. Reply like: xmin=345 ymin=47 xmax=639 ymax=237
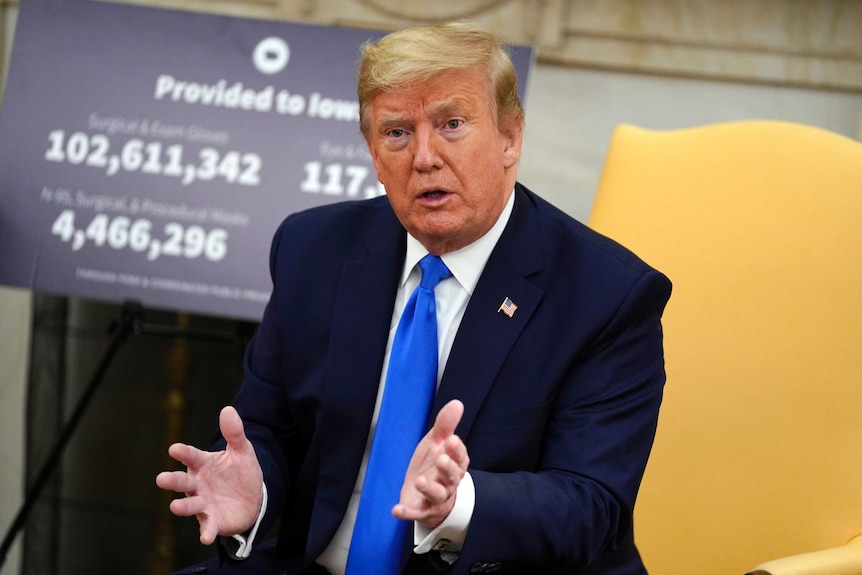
xmin=432 ymin=185 xmax=544 ymax=438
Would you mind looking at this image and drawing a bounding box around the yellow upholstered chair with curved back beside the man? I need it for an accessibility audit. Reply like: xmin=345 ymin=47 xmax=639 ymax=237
xmin=589 ymin=121 xmax=862 ymax=575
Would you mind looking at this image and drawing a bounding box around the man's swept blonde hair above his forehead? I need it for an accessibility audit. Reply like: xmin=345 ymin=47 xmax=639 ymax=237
xmin=357 ymin=21 xmax=524 ymax=136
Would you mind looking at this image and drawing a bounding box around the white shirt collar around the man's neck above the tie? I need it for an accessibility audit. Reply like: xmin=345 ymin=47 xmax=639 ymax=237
xmin=400 ymin=191 xmax=515 ymax=295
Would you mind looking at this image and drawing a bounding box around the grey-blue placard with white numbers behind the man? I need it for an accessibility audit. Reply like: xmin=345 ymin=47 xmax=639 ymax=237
xmin=0 ymin=0 xmax=533 ymax=320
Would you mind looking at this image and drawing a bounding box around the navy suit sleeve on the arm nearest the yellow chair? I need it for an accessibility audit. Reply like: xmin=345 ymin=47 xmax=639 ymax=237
xmin=461 ymin=271 xmax=669 ymax=573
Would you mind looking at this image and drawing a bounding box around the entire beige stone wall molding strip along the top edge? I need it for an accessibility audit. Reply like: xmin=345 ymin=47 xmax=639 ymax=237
xmin=89 ymin=0 xmax=862 ymax=92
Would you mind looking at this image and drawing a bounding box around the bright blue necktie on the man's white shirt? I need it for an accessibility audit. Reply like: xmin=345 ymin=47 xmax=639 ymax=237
xmin=347 ymin=254 xmax=450 ymax=575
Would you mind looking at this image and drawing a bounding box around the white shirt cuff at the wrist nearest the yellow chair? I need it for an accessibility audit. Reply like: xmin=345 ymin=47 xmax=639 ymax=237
xmin=413 ymin=472 xmax=476 ymax=562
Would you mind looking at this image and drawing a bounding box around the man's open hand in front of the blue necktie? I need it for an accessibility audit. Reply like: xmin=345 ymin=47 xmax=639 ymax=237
xmin=392 ymin=399 xmax=470 ymax=529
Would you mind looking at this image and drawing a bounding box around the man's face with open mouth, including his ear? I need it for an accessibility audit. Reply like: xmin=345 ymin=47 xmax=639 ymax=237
xmin=366 ymin=70 xmax=523 ymax=255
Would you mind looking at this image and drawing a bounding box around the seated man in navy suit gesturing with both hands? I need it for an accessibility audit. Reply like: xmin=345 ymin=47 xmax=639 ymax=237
xmin=157 ymin=23 xmax=670 ymax=575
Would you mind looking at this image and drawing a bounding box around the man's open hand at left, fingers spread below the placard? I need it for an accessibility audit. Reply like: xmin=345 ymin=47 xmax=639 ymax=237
xmin=156 ymin=407 xmax=263 ymax=545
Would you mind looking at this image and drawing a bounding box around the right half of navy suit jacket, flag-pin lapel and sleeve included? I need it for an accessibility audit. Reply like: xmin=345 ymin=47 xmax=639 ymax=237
xmin=446 ymin=190 xmax=671 ymax=573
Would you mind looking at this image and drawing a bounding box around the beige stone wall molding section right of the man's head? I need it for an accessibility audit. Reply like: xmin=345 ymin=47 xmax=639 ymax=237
xmin=540 ymin=0 xmax=862 ymax=92
